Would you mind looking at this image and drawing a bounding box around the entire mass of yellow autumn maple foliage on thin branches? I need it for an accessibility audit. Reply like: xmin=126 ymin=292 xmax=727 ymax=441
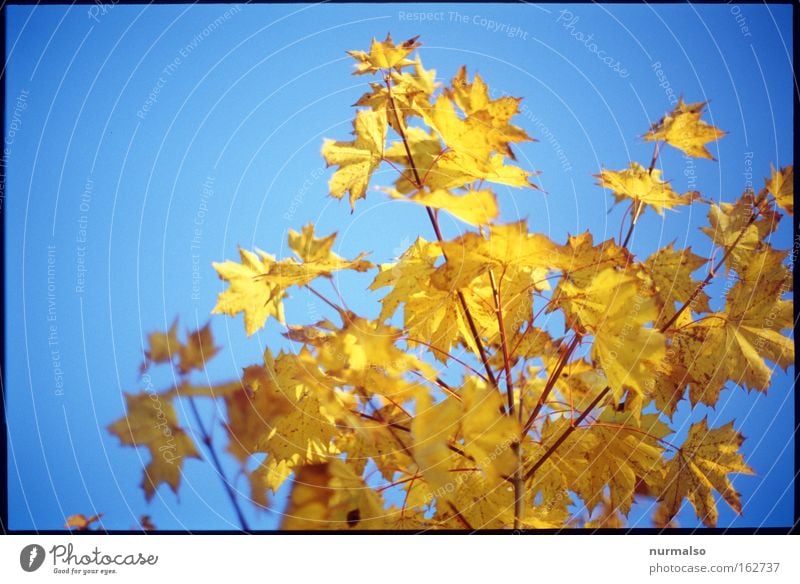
xmin=108 ymin=37 xmax=794 ymax=530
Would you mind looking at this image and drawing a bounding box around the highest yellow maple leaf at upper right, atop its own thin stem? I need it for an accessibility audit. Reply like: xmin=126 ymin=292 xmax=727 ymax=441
xmin=644 ymin=98 xmax=726 ymax=160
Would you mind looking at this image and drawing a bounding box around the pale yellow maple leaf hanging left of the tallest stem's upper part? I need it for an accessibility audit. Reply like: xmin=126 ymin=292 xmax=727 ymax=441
xmin=322 ymin=110 xmax=387 ymax=208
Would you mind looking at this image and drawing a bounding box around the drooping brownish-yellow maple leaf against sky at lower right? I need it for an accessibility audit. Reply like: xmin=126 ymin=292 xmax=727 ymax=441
xmin=659 ymin=418 xmax=753 ymax=527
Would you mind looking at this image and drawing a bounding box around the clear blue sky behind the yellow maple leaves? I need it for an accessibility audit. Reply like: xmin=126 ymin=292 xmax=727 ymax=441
xmin=3 ymin=4 xmax=794 ymax=529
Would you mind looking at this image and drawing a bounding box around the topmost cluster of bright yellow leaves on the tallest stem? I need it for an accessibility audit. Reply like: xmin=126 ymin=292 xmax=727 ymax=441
xmin=322 ymin=37 xmax=534 ymax=214
